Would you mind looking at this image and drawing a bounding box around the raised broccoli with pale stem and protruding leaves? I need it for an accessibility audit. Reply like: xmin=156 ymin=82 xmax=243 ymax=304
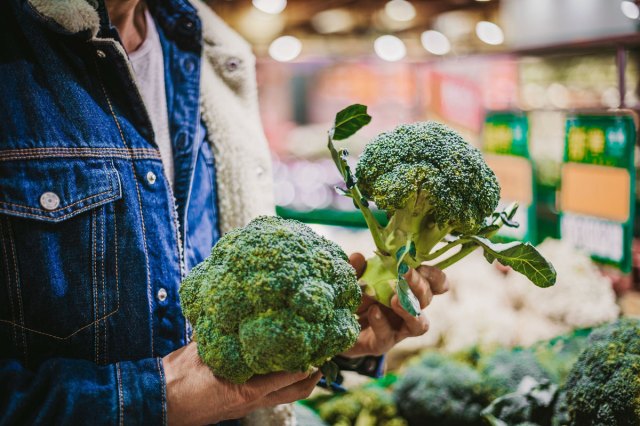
xmin=328 ymin=105 xmax=556 ymax=315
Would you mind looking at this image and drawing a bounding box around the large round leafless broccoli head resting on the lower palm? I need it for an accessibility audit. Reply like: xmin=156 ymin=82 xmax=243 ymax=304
xmin=180 ymin=216 xmax=361 ymax=383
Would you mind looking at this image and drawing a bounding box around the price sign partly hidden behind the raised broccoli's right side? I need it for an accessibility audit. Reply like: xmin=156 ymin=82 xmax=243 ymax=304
xmin=482 ymin=112 xmax=536 ymax=241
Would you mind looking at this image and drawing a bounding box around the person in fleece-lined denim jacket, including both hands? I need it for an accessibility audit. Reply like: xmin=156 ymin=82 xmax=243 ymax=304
xmin=0 ymin=0 xmax=446 ymax=425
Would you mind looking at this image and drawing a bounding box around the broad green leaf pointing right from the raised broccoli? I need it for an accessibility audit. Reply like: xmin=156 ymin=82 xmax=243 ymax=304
xmin=468 ymin=235 xmax=556 ymax=287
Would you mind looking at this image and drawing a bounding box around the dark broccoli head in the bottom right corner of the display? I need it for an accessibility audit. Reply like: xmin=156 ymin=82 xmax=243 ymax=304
xmin=565 ymin=319 xmax=640 ymax=426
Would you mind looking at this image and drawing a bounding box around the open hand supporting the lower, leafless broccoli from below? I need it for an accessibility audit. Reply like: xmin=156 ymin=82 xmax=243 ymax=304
xmin=162 ymin=342 xmax=322 ymax=426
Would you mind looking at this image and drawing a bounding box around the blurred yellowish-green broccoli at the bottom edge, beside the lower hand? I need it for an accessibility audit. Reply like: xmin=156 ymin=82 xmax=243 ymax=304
xmin=318 ymin=387 xmax=406 ymax=426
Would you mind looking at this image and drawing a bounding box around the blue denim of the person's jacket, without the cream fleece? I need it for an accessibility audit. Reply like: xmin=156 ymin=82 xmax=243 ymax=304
xmin=0 ymin=0 xmax=218 ymax=424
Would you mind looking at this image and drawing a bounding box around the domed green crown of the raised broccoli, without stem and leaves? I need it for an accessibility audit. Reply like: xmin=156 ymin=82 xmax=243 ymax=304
xmin=356 ymin=121 xmax=500 ymax=238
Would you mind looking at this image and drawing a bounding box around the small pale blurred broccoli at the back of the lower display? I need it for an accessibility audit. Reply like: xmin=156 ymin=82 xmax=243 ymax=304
xmin=478 ymin=349 xmax=551 ymax=398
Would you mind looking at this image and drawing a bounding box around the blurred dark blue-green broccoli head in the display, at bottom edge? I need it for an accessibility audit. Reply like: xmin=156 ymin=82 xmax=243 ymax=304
xmin=394 ymin=354 xmax=491 ymax=426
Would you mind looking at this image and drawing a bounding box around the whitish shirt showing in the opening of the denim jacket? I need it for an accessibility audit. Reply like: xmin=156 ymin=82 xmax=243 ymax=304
xmin=129 ymin=9 xmax=173 ymax=185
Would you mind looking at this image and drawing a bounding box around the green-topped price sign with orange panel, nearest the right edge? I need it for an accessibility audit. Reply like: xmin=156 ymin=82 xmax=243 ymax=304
xmin=560 ymin=113 xmax=636 ymax=272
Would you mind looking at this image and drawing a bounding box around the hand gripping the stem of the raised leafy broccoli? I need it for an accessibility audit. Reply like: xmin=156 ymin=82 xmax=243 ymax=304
xmin=342 ymin=253 xmax=449 ymax=357
